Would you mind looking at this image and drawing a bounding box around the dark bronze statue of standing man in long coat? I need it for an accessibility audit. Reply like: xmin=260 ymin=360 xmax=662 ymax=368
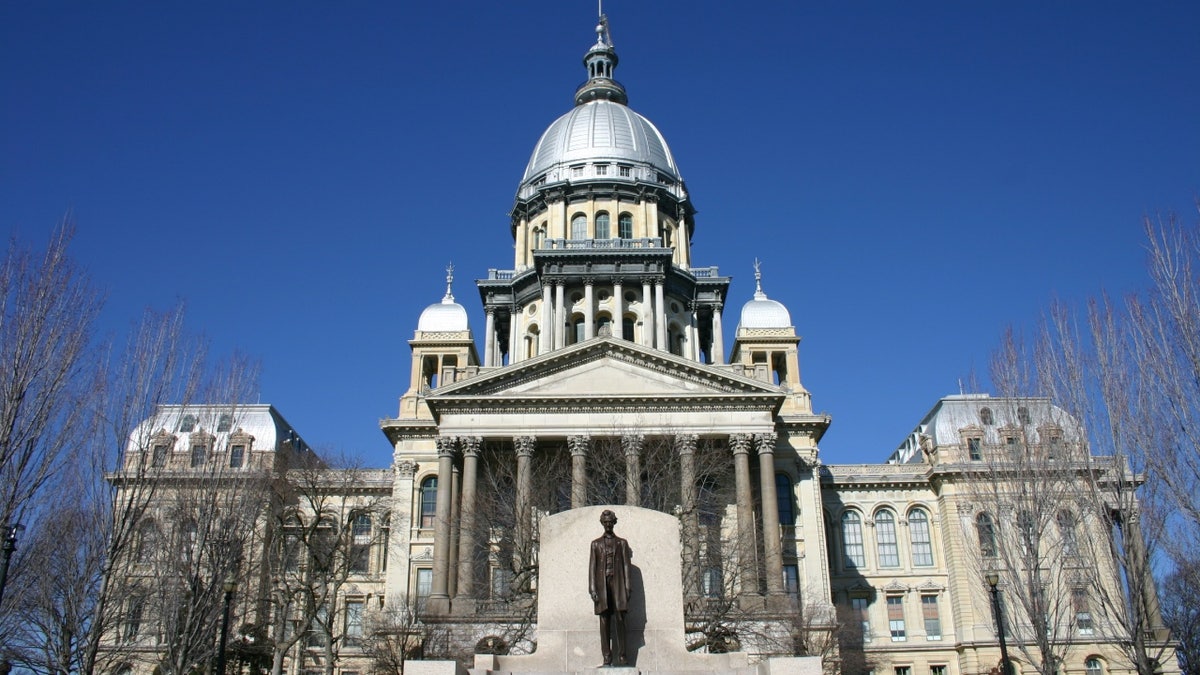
xmin=588 ymin=509 xmax=632 ymax=665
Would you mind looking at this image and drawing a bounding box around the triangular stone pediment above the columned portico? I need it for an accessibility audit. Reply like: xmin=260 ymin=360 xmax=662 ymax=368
xmin=427 ymin=338 xmax=785 ymax=407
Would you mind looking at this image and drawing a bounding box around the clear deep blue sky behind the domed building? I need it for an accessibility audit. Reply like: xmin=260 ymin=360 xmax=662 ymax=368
xmin=0 ymin=0 xmax=1200 ymax=466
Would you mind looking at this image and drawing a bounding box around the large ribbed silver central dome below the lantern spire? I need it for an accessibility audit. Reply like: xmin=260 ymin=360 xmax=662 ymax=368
xmin=521 ymin=100 xmax=679 ymax=184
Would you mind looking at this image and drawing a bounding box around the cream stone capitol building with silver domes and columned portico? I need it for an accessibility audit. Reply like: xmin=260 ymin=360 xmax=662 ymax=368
xmin=112 ymin=9 xmax=1174 ymax=675
